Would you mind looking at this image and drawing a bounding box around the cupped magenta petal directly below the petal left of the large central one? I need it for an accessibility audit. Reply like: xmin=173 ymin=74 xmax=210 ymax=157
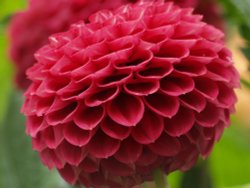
xmin=63 ymin=122 xmax=92 ymax=147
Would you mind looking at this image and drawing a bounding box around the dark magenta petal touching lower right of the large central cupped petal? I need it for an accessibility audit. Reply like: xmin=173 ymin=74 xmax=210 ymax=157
xmin=132 ymin=110 xmax=164 ymax=144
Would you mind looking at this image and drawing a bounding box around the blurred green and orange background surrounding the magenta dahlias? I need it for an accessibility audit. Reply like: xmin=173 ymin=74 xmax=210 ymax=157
xmin=0 ymin=0 xmax=250 ymax=188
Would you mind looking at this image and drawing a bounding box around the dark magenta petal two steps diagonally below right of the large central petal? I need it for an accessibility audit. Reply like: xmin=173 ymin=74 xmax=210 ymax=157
xmin=148 ymin=133 xmax=181 ymax=157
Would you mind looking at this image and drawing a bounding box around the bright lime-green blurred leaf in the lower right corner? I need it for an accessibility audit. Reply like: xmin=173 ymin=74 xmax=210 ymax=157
xmin=210 ymin=119 xmax=250 ymax=188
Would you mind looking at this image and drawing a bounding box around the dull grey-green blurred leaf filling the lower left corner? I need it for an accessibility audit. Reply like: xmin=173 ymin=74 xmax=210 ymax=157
xmin=0 ymin=92 xmax=58 ymax=188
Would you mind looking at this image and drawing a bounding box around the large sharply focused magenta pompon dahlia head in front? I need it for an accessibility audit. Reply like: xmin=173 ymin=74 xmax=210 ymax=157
xmin=22 ymin=1 xmax=239 ymax=188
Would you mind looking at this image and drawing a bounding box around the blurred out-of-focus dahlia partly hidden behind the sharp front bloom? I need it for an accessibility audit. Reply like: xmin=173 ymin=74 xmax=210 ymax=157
xmin=9 ymin=0 xmax=223 ymax=90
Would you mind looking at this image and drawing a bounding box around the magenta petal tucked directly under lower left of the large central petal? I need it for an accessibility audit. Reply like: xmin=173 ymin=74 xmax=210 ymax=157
xmin=101 ymin=116 xmax=131 ymax=140
